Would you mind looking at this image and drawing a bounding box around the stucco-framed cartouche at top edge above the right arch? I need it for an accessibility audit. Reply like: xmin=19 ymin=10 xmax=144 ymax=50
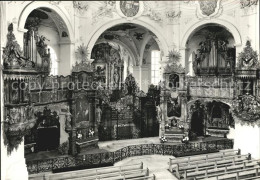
xmin=197 ymin=0 xmax=223 ymax=19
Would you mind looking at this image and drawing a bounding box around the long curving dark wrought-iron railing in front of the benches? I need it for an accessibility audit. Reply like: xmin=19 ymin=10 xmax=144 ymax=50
xmin=26 ymin=139 xmax=233 ymax=174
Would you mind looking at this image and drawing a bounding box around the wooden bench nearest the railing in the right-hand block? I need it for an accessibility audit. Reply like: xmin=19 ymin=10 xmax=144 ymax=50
xmin=169 ymin=149 xmax=241 ymax=172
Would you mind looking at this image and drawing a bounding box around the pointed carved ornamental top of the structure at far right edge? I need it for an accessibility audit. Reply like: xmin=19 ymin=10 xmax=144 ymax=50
xmin=237 ymin=41 xmax=259 ymax=69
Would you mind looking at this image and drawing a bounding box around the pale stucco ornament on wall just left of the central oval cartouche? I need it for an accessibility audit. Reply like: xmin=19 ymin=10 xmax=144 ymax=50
xmin=92 ymin=1 xmax=116 ymax=25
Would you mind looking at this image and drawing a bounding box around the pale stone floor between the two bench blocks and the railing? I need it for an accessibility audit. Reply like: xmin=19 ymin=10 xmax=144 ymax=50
xmin=115 ymin=155 xmax=177 ymax=180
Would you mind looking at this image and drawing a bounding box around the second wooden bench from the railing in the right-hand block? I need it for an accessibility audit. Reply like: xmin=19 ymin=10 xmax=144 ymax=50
xmin=172 ymin=155 xmax=251 ymax=178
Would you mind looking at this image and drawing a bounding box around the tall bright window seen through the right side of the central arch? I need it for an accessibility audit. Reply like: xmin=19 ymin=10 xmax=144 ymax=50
xmin=151 ymin=50 xmax=160 ymax=85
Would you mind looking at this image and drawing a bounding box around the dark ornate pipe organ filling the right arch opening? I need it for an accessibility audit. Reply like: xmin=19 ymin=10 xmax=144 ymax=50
xmin=193 ymin=26 xmax=235 ymax=75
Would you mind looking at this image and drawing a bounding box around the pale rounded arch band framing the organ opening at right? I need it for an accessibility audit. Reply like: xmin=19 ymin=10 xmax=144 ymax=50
xmin=181 ymin=19 xmax=242 ymax=48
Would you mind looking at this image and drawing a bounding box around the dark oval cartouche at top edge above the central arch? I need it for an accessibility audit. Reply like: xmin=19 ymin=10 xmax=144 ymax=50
xmin=120 ymin=1 xmax=140 ymax=17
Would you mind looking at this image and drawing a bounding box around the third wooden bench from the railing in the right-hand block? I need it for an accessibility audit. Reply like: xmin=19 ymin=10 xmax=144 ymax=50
xmin=184 ymin=160 xmax=259 ymax=180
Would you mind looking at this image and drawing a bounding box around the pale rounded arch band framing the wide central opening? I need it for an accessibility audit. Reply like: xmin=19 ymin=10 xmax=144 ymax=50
xmin=86 ymin=18 xmax=168 ymax=59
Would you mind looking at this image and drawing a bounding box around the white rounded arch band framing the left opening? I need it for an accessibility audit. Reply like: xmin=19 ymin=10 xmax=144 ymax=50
xmin=18 ymin=1 xmax=74 ymax=42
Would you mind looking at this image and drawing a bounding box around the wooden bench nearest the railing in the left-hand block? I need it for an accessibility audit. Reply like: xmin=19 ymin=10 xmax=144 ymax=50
xmin=48 ymin=163 xmax=143 ymax=180
